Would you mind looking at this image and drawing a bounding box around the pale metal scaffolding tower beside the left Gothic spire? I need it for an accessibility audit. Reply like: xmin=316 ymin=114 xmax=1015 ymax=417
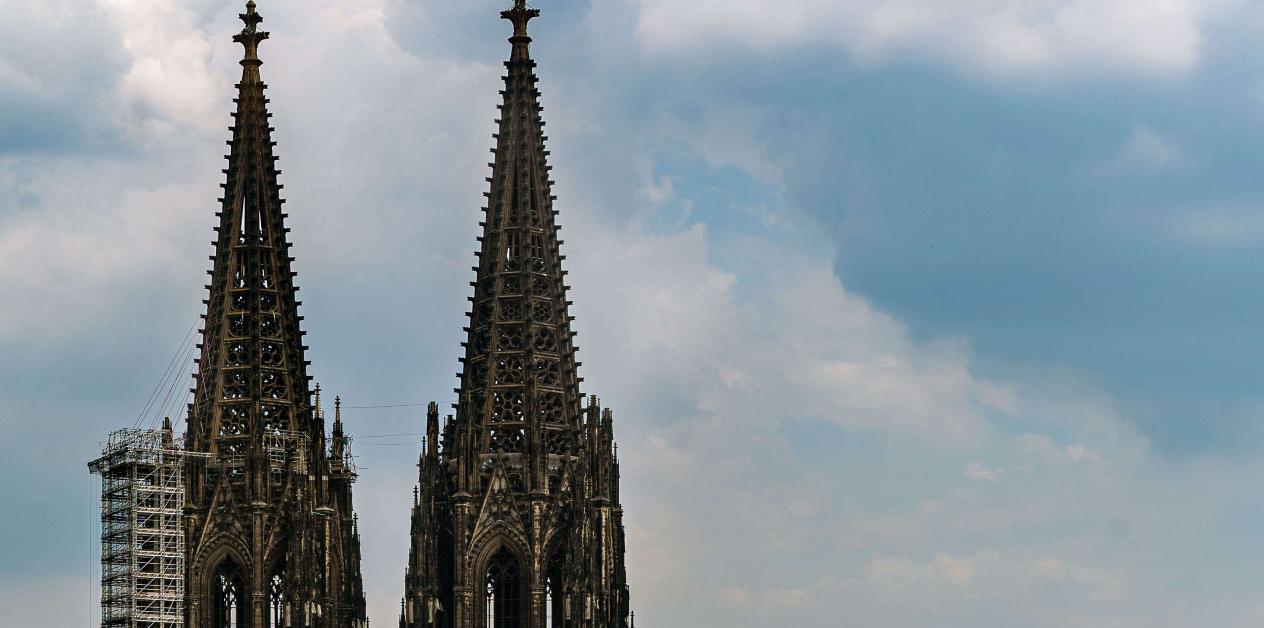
xmin=88 ymin=430 xmax=204 ymax=628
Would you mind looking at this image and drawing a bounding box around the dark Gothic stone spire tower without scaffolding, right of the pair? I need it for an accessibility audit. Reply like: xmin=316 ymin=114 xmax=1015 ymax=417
xmin=399 ymin=0 xmax=628 ymax=628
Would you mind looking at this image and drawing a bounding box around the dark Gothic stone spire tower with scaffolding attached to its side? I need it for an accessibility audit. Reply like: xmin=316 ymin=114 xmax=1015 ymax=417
xmin=185 ymin=1 xmax=365 ymax=628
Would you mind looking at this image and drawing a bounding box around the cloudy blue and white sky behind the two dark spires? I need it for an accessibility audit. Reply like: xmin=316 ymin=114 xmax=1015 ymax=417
xmin=0 ymin=0 xmax=1264 ymax=628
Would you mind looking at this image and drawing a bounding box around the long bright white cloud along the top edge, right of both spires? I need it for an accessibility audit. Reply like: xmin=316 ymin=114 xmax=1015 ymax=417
xmin=633 ymin=0 xmax=1239 ymax=75
